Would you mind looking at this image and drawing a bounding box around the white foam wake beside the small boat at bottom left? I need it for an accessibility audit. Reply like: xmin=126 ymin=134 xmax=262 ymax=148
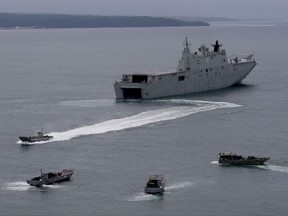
xmin=2 ymin=181 xmax=65 ymax=191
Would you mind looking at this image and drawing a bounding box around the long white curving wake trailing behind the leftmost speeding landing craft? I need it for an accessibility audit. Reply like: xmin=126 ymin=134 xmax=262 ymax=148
xmin=17 ymin=99 xmax=240 ymax=144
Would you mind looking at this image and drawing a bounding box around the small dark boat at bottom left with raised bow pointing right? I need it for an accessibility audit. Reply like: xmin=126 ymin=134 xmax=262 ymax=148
xmin=27 ymin=169 xmax=74 ymax=187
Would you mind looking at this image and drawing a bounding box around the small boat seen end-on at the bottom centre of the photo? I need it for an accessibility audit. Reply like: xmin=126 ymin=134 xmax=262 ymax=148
xmin=144 ymin=175 xmax=165 ymax=194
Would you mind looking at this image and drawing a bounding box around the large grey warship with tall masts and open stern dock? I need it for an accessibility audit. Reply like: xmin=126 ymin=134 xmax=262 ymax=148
xmin=114 ymin=38 xmax=257 ymax=99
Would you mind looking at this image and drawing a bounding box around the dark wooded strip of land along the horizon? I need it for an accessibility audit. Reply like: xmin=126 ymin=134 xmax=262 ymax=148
xmin=0 ymin=13 xmax=209 ymax=28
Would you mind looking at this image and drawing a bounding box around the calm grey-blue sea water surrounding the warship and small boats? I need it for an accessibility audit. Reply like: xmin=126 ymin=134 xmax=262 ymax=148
xmin=0 ymin=21 xmax=288 ymax=216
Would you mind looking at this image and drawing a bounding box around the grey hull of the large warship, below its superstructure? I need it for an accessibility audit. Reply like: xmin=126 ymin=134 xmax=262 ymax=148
xmin=114 ymin=60 xmax=256 ymax=99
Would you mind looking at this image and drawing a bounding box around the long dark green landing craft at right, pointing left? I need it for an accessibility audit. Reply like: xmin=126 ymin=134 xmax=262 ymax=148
xmin=218 ymin=152 xmax=270 ymax=166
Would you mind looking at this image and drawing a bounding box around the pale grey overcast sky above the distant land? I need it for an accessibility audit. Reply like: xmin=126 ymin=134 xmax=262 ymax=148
xmin=0 ymin=0 xmax=288 ymax=19
